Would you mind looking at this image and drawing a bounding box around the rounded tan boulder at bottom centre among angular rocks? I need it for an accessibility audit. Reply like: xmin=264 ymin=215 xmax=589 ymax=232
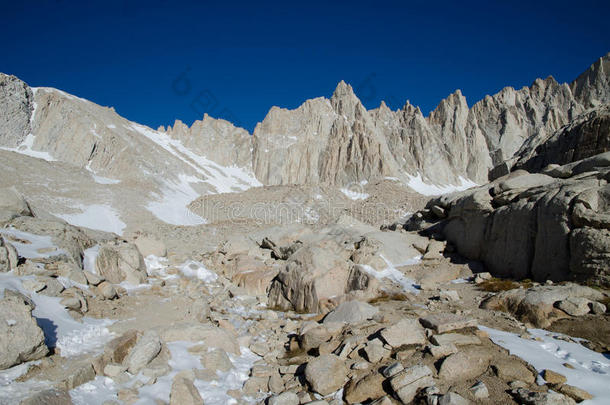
xmin=305 ymin=354 xmax=349 ymax=395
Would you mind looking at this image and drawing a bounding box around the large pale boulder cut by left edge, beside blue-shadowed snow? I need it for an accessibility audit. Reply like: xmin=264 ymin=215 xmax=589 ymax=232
xmin=0 ymin=290 xmax=49 ymax=370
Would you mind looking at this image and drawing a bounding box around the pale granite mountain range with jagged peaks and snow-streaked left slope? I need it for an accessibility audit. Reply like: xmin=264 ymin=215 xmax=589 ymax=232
xmin=0 ymin=54 xmax=610 ymax=233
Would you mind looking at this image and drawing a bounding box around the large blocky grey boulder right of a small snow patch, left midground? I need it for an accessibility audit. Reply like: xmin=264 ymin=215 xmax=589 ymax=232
xmin=95 ymin=241 xmax=146 ymax=284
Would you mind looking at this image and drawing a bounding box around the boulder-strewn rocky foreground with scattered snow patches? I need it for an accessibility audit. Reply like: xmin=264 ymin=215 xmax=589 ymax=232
xmin=0 ymin=184 xmax=610 ymax=405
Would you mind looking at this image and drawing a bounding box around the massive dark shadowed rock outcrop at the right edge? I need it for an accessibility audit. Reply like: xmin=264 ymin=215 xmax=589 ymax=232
xmin=407 ymin=153 xmax=610 ymax=286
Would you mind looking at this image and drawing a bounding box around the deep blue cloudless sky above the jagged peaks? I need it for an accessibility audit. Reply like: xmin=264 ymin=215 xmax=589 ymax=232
xmin=0 ymin=0 xmax=610 ymax=131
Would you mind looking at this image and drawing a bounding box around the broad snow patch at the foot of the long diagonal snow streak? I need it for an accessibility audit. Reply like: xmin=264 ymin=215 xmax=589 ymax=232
xmin=146 ymin=174 xmax=206 ymax=225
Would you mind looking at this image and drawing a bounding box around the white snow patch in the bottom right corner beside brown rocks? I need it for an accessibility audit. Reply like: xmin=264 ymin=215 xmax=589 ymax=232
xmin=479 ymin=326 xmax=610 ymax=405
